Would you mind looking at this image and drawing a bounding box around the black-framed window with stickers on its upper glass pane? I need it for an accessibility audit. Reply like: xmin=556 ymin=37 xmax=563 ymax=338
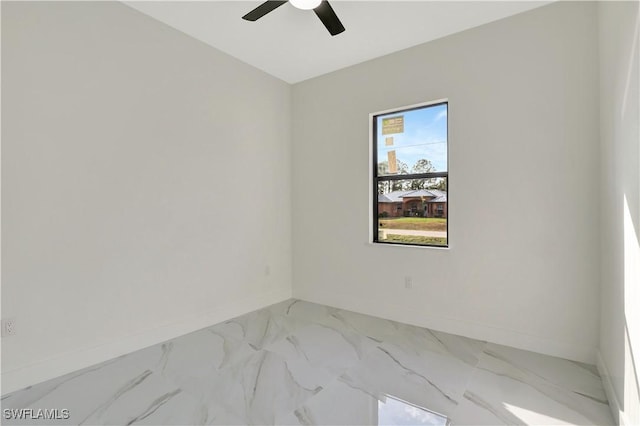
xmin=371 ymin=101 xmax=449 ymax=247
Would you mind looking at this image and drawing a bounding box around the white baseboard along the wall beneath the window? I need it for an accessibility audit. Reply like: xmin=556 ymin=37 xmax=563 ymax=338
xmin=293 ymin=289 xmax=596 ymax=365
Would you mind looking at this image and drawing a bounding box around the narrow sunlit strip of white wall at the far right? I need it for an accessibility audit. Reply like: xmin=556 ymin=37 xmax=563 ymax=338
xmin=598 ymin=2 xmax=640 ymax=425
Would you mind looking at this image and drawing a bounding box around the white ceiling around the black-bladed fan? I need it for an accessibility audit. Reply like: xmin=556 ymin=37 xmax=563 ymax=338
xmin=125 ymin=0 xmax=550 ymax=83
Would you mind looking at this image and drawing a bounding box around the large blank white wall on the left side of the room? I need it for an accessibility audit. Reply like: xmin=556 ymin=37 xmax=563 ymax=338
xmin=2 ymin=2 xmax=291 ymax=393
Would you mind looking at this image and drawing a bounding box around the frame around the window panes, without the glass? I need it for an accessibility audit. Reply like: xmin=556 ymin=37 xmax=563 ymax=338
xmin=369 ymin=98 xmax=451 ymax=249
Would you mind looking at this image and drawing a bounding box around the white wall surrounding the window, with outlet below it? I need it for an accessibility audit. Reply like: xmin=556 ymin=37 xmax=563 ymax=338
xmin=293 ymin=2 xmax=601 ymax=362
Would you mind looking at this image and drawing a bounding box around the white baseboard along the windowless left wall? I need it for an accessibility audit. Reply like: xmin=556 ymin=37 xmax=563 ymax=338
xmin=0 ymin=289 xmax=291 ymax=395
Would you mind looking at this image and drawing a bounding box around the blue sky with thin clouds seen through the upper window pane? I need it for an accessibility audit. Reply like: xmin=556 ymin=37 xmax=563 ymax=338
xmin=377 ymin=104 xmax=447 ymax=173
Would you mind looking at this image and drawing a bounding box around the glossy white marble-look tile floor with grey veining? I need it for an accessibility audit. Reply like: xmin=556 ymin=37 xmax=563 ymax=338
xmin=2 ymin=300 xmax=613 ymax=425
